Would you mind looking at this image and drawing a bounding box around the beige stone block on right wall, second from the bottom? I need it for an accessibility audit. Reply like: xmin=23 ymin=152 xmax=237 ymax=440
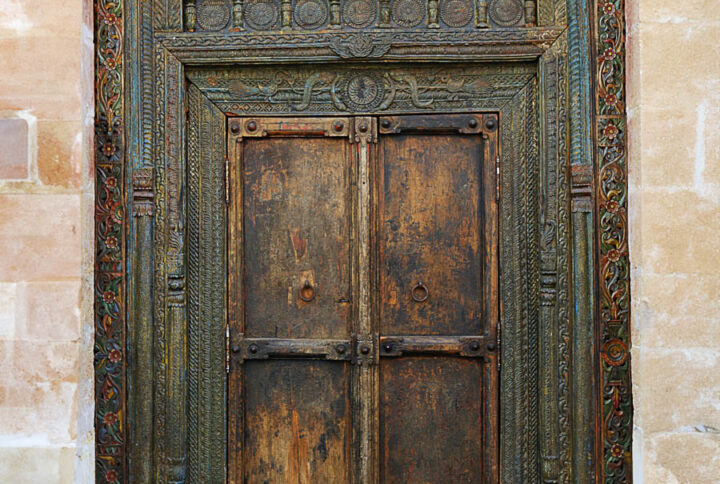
xmin=633 ymin=348 xmax=720 ymax=436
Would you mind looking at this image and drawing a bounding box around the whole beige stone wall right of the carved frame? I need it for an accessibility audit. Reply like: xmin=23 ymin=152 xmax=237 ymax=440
xmin=627 ymin=0 xmax=720 ymax=484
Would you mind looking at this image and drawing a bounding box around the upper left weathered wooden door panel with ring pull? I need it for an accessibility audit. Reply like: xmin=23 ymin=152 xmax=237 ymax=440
xmin=242 ymin=137 xmax=350 ymax=338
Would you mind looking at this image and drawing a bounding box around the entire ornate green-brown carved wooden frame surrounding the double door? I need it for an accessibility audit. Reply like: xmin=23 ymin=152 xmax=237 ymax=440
xmin=95 ymin=0 xmax=632 ymax=483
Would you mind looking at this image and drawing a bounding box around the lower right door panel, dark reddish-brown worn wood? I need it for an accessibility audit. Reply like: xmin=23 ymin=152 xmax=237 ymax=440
xmin=380 ymin=356 xmax=483 ymax=484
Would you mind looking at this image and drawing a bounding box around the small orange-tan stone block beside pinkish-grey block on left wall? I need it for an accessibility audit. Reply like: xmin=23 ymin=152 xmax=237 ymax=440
xmin=37 ymin=120 xmax=83 ymax=188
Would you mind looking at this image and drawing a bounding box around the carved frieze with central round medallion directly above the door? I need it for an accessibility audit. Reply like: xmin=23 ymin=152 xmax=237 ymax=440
xmin=188 ymin=62 xmax=534 ymax=115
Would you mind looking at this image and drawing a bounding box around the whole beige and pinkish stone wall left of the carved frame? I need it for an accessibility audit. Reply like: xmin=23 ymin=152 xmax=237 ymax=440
xmin=0 ymin=0 xmax=94 ymax=484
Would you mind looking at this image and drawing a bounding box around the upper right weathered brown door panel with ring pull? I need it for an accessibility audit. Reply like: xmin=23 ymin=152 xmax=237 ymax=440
xmin=380 ymin=134 xmax=483 ymax=335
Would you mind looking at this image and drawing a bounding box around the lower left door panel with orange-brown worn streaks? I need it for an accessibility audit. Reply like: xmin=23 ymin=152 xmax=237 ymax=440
xmin=244 ymin=360 xmax=351 ymax=484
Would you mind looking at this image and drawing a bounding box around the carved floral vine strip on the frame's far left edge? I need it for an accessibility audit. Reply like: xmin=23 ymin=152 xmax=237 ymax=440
xmin=94 ymin=0 xmax=127 ymax=483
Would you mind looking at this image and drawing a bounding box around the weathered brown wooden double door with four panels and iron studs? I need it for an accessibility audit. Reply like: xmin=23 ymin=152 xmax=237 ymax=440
xmin=227 ymin=114 xmax=500 ymax=483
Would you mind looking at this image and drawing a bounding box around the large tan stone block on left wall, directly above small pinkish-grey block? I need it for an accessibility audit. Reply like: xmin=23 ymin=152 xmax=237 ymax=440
xmin=0 ymin=36 xmax=82 ymax=120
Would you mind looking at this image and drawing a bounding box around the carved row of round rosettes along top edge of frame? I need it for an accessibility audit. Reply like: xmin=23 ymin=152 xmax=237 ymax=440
xmin=184 ymin=0 xmax=546 ymax=32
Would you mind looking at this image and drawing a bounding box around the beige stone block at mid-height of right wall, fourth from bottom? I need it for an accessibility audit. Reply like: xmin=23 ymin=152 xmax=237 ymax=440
xmin=630 ymin=189 xmax=720 ymax=274
